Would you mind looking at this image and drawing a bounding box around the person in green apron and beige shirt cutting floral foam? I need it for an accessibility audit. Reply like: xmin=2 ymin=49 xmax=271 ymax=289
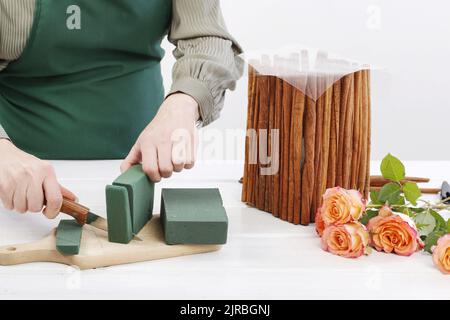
xmin=0 ymin=0 xmax=243 ymax=218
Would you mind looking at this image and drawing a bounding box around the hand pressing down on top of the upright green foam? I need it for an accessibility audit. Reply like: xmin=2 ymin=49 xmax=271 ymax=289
xmin=121 ymin=93 xmax=200 ymax=182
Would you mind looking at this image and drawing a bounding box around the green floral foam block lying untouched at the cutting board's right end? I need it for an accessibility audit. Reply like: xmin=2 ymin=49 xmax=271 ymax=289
xmin=161 ymin=189 xmax=228 ymax=245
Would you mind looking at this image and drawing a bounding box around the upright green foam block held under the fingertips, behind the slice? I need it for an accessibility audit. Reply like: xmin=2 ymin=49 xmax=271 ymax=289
xmin=113 ymin=165 xmax=154 ymax=234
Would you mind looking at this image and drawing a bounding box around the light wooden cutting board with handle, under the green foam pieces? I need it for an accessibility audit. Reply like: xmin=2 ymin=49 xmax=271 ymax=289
xmin=0 ymin=217 xmax=221 ymax=270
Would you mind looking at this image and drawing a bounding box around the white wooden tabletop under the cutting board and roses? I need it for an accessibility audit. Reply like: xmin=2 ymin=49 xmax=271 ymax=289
xmin=0 ymin=161 xmax=450 ymax=299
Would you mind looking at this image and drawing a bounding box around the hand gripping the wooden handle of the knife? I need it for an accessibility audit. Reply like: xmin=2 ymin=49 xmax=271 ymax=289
xmin=0 ymin=139 xmax=76 ymax=219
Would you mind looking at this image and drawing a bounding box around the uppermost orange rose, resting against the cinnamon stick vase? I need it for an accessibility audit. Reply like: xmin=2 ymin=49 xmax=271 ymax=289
xmin=316 ymin=187 xmax=366 ymax=226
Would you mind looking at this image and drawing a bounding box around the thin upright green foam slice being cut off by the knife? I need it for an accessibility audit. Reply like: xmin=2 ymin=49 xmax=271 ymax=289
xmin=106 ymin=186 xmax=133 ymax=244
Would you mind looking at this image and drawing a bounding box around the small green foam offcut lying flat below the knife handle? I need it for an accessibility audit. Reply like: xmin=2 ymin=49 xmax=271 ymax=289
xmin=56 ymin=220 xmax=83 ymax=255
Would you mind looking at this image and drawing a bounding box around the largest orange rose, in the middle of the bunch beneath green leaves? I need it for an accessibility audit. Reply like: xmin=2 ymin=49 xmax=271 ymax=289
xmin=367 ymin=206 xmax=423 ymax=256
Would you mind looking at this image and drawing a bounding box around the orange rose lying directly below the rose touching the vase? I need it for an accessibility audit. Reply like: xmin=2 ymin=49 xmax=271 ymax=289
xmin=322 ymin=222 xmax=369 ymax=258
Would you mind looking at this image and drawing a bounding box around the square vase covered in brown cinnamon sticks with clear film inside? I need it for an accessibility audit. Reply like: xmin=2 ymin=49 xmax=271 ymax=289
xmin=242 ymin=50 xmax=371 ymax=225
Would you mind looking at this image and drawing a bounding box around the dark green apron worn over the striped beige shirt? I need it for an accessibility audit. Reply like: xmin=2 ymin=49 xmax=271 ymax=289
xmin=0 ymin=0 xmax=172 ymax=159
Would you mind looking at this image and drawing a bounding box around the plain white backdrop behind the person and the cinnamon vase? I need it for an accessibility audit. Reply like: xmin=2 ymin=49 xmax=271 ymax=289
xmin=163 ymin=0 xmax=450 ymax=160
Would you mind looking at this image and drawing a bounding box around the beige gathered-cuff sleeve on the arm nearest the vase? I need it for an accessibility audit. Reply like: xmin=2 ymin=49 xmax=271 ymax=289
xmin=169 ymin=0 xmax=244 ymax=126
